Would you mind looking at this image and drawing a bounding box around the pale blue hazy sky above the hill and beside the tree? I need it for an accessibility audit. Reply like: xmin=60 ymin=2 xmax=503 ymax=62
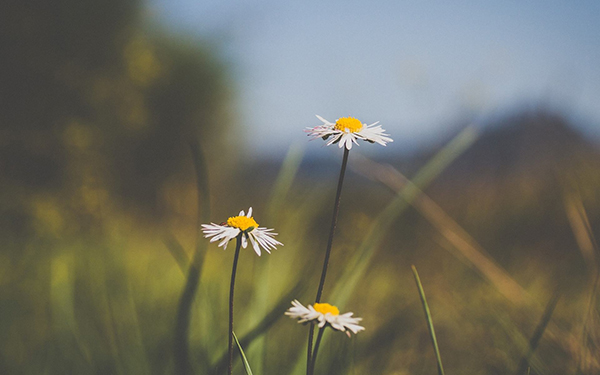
xmin=148 ymin=0 xmax=600 ymax=155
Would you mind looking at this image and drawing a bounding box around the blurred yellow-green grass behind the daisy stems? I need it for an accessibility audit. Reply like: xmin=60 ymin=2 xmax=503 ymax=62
xmin=0 ymin=119 xmax=598 ymax=374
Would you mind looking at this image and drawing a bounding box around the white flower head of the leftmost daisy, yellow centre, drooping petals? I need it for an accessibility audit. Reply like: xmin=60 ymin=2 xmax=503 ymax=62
xmin=202 ymin=207 xmax=283 ymax=256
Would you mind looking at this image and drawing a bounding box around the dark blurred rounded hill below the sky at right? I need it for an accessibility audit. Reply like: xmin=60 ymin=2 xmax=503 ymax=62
xmin=419 ymin=111 xmax=600 ymax=201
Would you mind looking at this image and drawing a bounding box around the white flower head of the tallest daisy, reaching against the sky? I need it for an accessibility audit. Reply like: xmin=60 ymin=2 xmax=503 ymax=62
xmin=304 ymin=115 xmax=393 ymax=150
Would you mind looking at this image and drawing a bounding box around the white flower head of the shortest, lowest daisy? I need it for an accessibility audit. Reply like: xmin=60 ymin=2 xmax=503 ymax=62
xmin=285 ymin=300 xmax=365 ymax=337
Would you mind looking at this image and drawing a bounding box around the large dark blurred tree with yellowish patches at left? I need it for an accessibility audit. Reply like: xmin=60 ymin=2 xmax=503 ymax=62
xmin=0 ymin=0 xmax=227 ymax=232
